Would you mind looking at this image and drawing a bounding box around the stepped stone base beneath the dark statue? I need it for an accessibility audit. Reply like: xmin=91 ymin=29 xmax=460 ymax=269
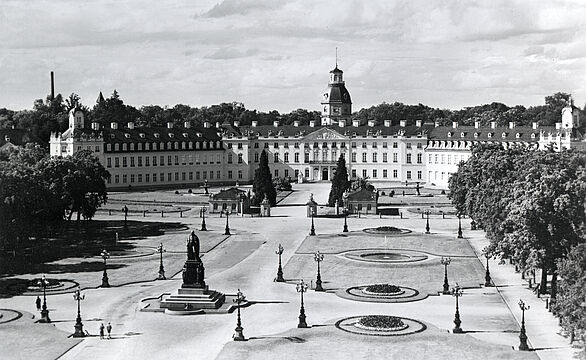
xmin=160 ymin=285 xmax=226 ymax=311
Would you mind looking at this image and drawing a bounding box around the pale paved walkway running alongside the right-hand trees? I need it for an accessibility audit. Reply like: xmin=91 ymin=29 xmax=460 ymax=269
xmin=465 ymin=231 xmax=577 ymax=360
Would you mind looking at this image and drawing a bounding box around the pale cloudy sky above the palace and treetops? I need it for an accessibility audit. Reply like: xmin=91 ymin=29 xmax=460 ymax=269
xmin=0 ymin=0 xmax=586 ymax=113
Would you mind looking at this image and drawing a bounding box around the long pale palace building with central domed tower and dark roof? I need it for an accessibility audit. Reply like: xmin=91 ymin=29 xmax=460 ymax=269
xmin=50 ymin=64 xmax=586 ymax=189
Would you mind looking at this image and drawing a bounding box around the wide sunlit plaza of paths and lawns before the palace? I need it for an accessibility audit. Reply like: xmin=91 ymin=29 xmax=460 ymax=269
xmin=0 ymin=182 xmax=574 ymax=359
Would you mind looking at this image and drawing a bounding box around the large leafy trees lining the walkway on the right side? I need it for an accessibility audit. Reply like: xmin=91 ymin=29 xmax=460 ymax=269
xmin=449 ymin=145 xmax=586 ymax=336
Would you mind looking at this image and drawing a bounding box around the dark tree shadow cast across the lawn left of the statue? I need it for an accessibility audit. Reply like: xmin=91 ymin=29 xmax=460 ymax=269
xmin=0 ymin=220 xmax=182 ymax=276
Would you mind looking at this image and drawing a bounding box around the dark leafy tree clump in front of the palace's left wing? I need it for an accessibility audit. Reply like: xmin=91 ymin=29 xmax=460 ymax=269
xmin=0 ymin=144 xmax=110 ymax=250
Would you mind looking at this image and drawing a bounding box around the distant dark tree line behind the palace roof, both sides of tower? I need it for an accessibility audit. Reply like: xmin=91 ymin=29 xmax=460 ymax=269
xmin=0 ymin=90 xmax=586 ymax=141
